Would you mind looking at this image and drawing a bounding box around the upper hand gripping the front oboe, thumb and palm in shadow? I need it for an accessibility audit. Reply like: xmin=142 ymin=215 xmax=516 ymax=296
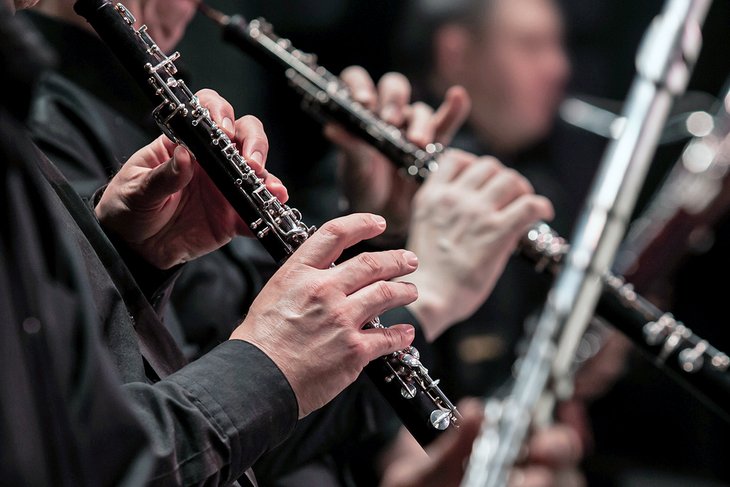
xmin=95 ymin=90 xmax=287 ymax=269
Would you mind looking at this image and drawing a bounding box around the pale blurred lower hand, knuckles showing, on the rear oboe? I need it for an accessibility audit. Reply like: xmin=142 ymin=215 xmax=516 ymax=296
xmin=398 ymin=149 xmax=553 ymax=340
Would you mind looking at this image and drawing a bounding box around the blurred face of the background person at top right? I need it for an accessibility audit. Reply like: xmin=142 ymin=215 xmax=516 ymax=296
xmin=464 ymin=0 xmax=569 ymax=149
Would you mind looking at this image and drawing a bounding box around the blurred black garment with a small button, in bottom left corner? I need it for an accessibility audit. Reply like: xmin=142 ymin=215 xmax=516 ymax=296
xmin=0 ymin=110 xmax=153 ymax=486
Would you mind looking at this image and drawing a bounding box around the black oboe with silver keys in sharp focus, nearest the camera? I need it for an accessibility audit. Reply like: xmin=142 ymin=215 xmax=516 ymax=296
xmin=74 ymin=0 xmax=460 ymax=445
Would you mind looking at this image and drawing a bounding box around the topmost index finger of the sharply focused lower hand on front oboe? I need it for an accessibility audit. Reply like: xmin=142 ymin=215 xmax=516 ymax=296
xmin=291 ymin=213 xmax=386 ymax=269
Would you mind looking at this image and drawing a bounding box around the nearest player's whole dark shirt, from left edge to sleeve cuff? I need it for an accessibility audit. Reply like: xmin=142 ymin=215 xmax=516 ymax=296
xmin=0 ymin=13 xmax=298 ymax=485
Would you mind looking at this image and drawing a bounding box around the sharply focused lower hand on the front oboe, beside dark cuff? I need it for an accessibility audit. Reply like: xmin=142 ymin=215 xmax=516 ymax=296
xmin=231 ymin=214 xmax=418 ymax=417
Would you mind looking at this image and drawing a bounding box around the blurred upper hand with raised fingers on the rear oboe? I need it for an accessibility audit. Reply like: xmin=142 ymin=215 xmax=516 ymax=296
xmin=325 ymin=66 xmax=470 ymax=244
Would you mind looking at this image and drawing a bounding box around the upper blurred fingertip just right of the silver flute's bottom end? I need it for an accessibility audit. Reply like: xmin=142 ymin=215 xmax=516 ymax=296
xmin=528 ymin=424 xmax=583 ymax=467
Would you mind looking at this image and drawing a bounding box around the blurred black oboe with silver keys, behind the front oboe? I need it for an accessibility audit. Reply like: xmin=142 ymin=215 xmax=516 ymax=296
xmin=198 ymin=3 xmax=730 ymax=411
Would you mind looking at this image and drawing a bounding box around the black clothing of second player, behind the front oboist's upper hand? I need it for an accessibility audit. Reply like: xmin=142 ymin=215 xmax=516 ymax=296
xmin=23 ymin=13 xmax=264 ymax=358
